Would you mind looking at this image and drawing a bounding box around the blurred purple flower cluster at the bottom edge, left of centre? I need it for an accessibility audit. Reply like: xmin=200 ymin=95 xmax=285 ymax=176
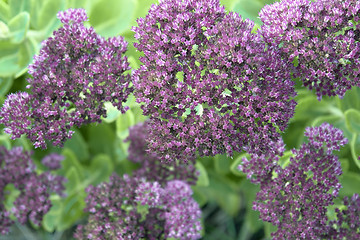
xmin=74 ymin=174 xmax=201 ymax=240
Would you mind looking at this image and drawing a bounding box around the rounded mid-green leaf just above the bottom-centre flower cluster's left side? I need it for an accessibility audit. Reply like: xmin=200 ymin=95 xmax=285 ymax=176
xmin=89 ymin=154 xmax=114 ymax=185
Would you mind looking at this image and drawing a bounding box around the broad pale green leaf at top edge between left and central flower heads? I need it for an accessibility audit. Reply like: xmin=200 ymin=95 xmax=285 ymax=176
xmin=89 ymin=0 xmax=136 ymax=37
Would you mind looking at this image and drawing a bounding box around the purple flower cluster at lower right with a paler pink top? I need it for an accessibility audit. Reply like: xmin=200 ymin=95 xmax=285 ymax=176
xmin=254 ymin=123 xmax=347 ymax=240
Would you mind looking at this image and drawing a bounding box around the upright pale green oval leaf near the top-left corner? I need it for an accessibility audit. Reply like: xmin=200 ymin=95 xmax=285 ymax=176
xmin=8 ymin=12 xmax=30 ymax=44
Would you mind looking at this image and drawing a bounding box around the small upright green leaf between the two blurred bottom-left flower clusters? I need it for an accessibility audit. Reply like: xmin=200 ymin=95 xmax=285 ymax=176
xmin=42 ymin=196 xmax=63 ymax=232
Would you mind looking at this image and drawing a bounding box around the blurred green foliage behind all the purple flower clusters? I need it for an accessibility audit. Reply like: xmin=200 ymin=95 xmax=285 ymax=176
xmin=0 ymin=0 xmax=360 ymax=240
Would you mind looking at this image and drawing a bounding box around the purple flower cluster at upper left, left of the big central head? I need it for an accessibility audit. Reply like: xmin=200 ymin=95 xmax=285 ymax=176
xmin=0 ymin=9 xmax=132 ymax=148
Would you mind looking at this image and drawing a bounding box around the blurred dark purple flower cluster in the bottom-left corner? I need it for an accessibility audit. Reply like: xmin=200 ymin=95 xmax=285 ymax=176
xmin=0 ymin=147 xmax=65 ymax=234
